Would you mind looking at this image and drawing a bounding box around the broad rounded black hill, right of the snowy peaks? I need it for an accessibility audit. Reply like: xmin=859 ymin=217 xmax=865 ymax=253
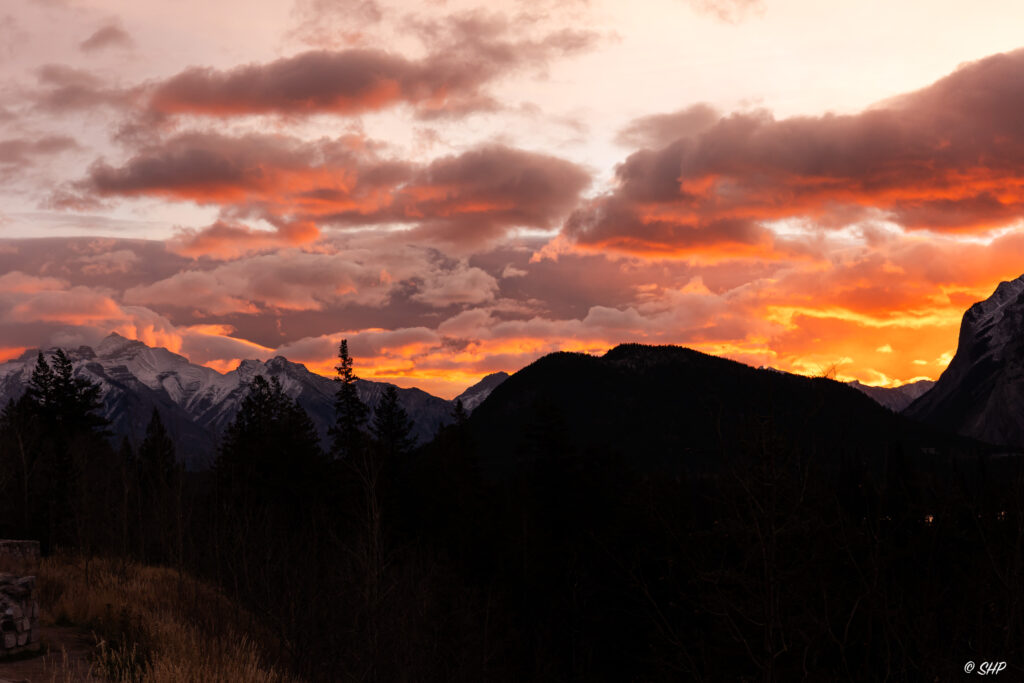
xmin=469 ymin=344 xmax=983 ymax=469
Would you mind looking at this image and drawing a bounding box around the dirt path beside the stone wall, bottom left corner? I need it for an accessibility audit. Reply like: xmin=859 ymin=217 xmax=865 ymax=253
xmin=0 ymin=626 xmax=101 ymax=683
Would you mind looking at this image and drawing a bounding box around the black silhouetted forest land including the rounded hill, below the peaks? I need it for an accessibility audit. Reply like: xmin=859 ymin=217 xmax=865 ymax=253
xmin=0 ymin=342 xmax=1024 ymax=682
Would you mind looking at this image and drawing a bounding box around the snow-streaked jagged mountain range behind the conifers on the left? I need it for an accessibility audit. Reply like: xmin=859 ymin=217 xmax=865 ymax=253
xmin=0 ymin=334 xmax=452 ymax=466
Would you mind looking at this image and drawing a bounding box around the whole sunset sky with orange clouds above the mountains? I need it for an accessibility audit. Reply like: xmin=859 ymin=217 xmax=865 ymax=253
xmin=0 ymin=0 xmax=1024 ymax=397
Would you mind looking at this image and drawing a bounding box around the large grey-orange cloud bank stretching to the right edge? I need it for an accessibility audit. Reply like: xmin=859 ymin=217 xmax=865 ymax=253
xmin=564 ymin=50 xmax=1024 ymax=254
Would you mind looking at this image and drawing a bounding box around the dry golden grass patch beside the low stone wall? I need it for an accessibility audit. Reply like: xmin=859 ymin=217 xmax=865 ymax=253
xmin=24 ymin=557 xmax=295 ymax=683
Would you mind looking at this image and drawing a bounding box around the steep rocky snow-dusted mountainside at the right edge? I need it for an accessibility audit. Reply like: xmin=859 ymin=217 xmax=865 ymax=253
xmin=905 ymin=276 xmax=1024 ymax=446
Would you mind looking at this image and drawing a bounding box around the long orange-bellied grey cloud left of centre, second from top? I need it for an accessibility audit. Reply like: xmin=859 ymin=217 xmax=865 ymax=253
xmin=77 ymin=133 xmax=590 ymax=250
